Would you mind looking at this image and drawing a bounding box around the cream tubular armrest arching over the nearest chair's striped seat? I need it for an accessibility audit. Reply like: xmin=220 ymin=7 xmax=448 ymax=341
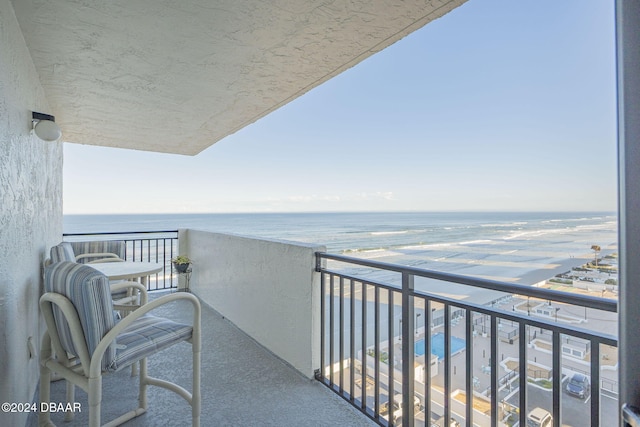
xmin=89 ymin=293 xmax=201 ymax=378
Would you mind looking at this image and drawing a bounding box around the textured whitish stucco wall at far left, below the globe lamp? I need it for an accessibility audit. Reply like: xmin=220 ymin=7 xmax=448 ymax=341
xmin=0 ymin=0 xmax=62 ymax=426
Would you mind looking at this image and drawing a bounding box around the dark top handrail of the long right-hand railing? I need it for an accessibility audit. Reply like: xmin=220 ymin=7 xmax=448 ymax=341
xmin=316 ymin=252 xmax=618 ymax=313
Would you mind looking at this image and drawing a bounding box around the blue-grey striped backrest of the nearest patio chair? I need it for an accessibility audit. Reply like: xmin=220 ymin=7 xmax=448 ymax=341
xmin=44 ymin=261 xmax=116 ymax=370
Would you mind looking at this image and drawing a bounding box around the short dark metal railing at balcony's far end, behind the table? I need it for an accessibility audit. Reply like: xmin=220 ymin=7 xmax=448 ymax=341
xmin=63 ymin=230 xmax=178 ymax=291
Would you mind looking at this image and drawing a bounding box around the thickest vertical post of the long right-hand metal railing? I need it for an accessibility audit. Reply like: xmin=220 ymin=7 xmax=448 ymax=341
xmin=400 ymin=273 xmax=415 ymax=426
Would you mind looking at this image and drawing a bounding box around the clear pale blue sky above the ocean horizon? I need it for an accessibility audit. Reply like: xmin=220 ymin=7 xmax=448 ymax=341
xmin=64 ymin=0 xmax=617 ymax=214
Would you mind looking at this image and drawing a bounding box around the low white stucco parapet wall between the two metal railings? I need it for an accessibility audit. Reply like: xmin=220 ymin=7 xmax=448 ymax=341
xmin=179 ymin=230 xmax=325 ymax=378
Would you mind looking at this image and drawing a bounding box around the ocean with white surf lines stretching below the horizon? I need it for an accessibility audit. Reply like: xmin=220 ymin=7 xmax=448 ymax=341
xmin=64 ymin=212 xmax=618 ymax=284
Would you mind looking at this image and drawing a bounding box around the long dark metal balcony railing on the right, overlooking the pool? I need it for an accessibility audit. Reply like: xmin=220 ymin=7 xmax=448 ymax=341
xmin=316 ymin=253 xmax=618 ymax=427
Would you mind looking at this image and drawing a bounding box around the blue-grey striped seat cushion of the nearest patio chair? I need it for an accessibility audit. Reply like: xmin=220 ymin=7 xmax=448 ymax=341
xmin=107 ymin=314 xmax=193 ymax=371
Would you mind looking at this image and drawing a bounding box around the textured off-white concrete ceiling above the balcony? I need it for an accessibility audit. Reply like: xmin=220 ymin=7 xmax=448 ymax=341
xmin=12 ymin=0 xmax=466 ymax=154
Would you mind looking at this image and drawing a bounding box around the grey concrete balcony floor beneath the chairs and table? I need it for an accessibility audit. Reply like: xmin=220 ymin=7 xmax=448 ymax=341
xmin=27 ymin=292 xmax=376 ymax=427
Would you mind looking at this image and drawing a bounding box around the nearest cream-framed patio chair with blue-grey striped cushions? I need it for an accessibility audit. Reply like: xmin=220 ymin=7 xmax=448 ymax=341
xmin=39 ymin=262 xmax=201 ymax=427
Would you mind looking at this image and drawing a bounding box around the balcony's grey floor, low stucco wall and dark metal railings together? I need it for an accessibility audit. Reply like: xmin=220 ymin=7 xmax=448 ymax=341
xmin=37 ymin=230 xmax=618 ymax=427
